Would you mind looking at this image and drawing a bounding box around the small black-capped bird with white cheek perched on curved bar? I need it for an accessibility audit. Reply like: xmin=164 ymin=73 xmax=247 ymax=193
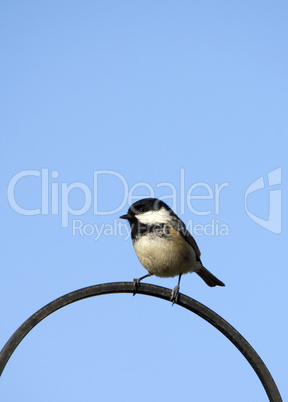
xmin=120 ymin=198 xmax=225 ymax=304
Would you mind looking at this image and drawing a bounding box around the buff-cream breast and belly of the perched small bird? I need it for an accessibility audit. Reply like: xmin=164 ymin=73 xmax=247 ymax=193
xmin=133 ymin=231 xmax=198 ymax=277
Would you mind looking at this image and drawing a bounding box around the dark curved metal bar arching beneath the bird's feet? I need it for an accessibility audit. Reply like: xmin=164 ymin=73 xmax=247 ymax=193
xmin=0 ymin=282 xmax=282 ymax=402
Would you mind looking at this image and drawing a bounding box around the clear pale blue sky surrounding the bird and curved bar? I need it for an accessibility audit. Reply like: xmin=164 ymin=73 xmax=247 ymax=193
xmin=0 ymin=1 xmax=288 ymax=402
